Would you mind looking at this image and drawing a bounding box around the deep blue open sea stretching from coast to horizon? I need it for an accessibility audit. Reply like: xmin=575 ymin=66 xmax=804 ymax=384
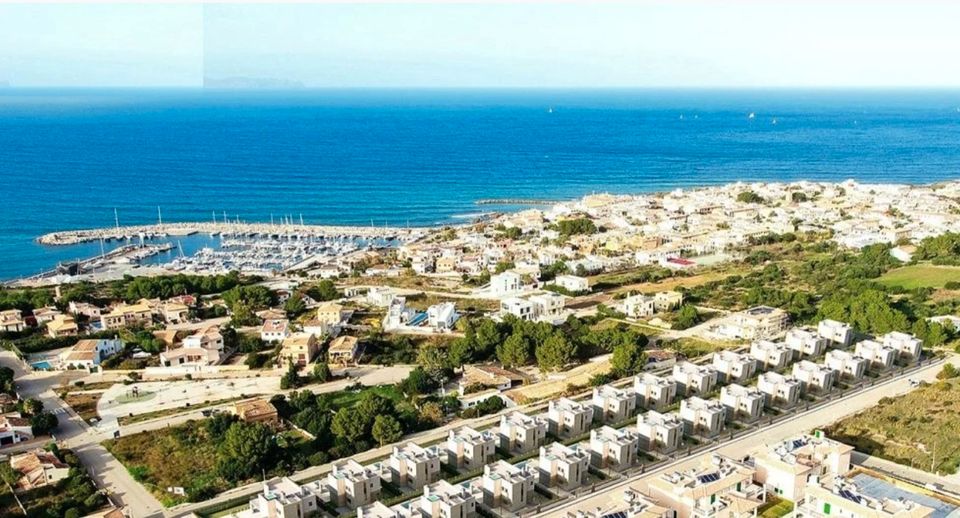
xmin=0 ymin=88 xmax=960 ymax=279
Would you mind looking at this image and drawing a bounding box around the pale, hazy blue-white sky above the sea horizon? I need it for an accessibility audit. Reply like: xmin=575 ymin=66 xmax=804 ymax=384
xmin=0 ymin=0 xmax=960 ymax=88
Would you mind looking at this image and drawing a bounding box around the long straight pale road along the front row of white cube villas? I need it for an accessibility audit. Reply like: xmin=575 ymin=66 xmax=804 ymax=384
xmin=540 ymin=357 xmax=948 ymax=518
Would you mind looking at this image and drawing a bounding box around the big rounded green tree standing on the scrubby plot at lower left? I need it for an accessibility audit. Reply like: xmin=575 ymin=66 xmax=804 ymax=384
xmin=217 ymin=422 xmax=277 ymax=482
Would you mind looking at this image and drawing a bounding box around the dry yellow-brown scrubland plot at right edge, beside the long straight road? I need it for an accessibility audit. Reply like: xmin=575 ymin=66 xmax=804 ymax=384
xmin=827 ymin=380 xmax=960 ymax=473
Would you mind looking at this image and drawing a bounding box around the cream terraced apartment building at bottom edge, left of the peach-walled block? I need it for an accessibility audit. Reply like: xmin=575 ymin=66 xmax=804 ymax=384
xmin=647 ymin=455 xmax=766 ymax=518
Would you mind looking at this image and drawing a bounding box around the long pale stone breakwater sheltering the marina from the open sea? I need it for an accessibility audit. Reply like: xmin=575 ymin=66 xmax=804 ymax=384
xmin=37 ymin=222 xmax=420 ymax=246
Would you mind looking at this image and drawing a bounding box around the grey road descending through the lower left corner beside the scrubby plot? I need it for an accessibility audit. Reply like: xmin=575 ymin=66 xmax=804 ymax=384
xmin=0 ymin=351 xmax=163 ymax=517
